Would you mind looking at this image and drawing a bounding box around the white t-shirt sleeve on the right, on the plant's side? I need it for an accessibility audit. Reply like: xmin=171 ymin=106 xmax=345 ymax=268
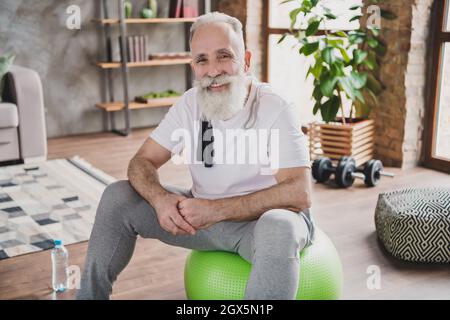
xmin=269 ymin=104 xmax=311 ymax=169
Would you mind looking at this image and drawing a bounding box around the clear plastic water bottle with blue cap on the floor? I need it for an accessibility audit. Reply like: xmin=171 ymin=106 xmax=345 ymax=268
xmin=52 ymin=239 xmax=69 ymax=292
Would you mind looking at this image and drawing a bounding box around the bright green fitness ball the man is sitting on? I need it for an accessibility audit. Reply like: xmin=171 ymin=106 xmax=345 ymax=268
xmin=184 ymin=229 xmax=343 ymax=300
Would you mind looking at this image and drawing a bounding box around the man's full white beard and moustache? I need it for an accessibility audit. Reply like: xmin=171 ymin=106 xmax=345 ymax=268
xmin=194 ymin=71 xmax=248 ymax=121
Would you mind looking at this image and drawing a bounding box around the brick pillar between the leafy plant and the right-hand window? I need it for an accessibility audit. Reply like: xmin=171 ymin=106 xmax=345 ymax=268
xmin=364 ymin=0 xmax=432 ymax=168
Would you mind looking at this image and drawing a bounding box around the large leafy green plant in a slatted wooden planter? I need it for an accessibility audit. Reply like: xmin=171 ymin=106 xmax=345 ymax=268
xmin=278 ymin=0 xmax=396 ymax=165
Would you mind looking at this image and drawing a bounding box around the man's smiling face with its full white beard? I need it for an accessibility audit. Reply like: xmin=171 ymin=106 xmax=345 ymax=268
xmin=191 ymin=22 xmax=251 ymax=120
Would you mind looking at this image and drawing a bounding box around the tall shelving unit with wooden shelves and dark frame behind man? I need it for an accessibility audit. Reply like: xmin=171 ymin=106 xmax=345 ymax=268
xmin=96 ymin=0 xmax=211 ymax=136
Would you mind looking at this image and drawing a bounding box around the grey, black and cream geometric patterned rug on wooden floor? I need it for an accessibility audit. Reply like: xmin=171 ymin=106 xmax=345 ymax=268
xmin=0 ymin=157 xmax=115 ymax=259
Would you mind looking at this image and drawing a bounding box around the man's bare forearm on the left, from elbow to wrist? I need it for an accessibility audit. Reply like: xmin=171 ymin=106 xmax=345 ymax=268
xmin=128 ymin=157 xmax=168 ymax=207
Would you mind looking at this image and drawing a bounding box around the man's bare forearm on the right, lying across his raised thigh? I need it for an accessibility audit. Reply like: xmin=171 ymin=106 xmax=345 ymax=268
xmin=213 ymin=179 xmax=311 ymax=221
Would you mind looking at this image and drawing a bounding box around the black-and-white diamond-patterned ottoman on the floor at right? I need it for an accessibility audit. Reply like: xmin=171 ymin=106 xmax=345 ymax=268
xmin=375 ymin=188 xmax=450 ymax=263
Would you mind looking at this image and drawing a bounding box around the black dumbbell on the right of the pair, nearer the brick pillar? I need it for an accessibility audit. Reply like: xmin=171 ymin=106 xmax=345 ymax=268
xmin=335 ymin=158 xmax=394 ymax=188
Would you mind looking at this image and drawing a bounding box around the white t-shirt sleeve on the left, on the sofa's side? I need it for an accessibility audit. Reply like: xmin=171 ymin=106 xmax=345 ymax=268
xmin=150 ymin=96 xmax=186 ymax=154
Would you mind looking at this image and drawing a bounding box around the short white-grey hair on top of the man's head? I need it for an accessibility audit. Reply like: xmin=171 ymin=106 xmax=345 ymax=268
xmin=189 ymin=11 xmax=245 ymax=55
